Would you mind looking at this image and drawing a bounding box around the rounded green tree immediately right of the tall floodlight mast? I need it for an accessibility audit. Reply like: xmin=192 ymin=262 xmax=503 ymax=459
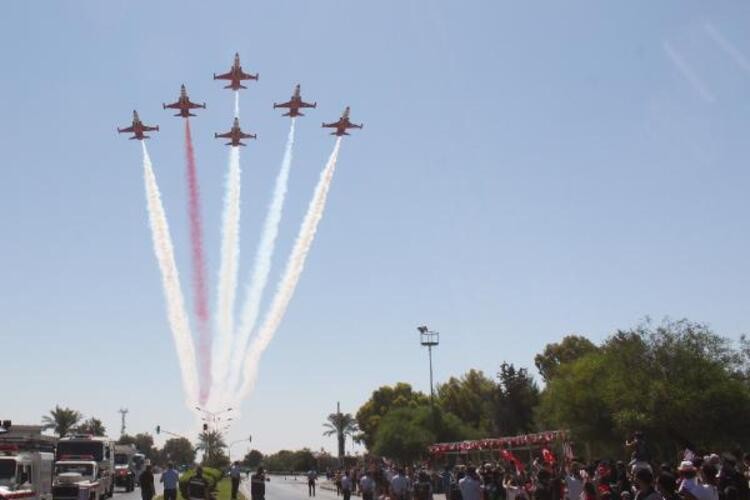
xmin=437 ymin=370 xmax=498 ymax=436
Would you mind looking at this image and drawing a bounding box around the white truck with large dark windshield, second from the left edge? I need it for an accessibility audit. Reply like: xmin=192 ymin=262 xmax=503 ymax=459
xmin=53 ymin=434 xmax=115 ymax=500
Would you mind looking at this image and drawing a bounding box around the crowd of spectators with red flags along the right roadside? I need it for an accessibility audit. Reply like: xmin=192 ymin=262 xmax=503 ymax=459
xmin=322 ymin=433 xmax=750 ymax=500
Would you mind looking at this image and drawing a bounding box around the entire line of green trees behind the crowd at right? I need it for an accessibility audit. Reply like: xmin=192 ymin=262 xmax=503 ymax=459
xmin=354 ymin=320 xmax=750 ymax=462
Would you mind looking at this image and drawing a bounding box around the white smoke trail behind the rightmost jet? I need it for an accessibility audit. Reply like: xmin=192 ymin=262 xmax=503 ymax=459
xmin=236 ymin=137 xmax=341 ymax=402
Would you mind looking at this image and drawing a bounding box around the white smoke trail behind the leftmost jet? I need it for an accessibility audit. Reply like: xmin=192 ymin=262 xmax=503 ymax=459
xmin=141 ymin=141 xmax=198 ymax=408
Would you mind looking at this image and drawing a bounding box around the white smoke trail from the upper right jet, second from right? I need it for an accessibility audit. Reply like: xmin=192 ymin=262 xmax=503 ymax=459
xmin=227 ymin=118 xmax=297 ymax=395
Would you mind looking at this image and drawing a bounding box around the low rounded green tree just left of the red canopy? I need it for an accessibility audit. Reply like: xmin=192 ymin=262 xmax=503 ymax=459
xmin=372 ymin=405 xmax=477 ymax=464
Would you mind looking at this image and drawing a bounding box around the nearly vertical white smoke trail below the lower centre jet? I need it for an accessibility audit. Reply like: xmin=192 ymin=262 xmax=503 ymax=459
xmin=209 ymin=146 xmax=242 ymax=406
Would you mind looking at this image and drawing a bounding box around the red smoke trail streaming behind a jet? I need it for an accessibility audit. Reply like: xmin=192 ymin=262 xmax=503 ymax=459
xmin=185 ymin=120 xmax=211 ymax=404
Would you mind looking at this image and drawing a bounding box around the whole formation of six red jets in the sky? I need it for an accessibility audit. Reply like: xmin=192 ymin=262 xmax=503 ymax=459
xmin=117 ymin=53 xmax=363 ymax=142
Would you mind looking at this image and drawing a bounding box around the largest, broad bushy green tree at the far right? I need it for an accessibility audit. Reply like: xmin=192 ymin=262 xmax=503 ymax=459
xmin=537 ymin=320 xmax=750 ymax=457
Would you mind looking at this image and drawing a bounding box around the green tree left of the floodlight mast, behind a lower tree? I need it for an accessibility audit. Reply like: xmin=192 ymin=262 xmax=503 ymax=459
xmin=356 ymin=382 xmax=429 ymax=449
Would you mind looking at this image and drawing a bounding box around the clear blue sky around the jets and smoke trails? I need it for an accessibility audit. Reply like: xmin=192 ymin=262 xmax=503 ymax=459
xmin=0 ymin=0 xmax=750 ymax=453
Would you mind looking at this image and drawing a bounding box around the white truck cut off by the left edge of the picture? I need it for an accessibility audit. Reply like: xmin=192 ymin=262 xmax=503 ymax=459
xmin=0 ymin=442 xmax=55 ymax=500
